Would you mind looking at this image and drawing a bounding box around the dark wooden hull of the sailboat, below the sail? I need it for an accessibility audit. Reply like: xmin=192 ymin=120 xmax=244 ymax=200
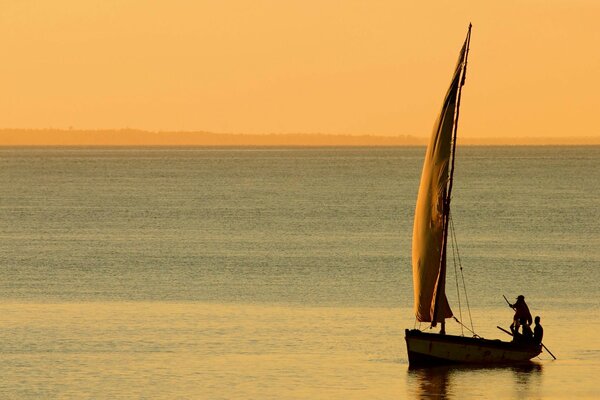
xmin=405 ymin=329 xmax=542 ymax=367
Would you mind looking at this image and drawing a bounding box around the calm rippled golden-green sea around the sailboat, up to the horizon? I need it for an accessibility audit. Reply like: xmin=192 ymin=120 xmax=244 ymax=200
xmin=0 ymin=146 xmax=600 ymax=399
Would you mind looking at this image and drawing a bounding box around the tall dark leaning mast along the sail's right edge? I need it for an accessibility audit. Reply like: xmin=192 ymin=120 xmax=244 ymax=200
xmin=431 ymin=23 xmax=473 ymax=324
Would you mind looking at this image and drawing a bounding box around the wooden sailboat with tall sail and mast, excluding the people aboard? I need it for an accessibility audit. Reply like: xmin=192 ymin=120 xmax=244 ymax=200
xmin=405 ymin=24 xmax=541 ymax=367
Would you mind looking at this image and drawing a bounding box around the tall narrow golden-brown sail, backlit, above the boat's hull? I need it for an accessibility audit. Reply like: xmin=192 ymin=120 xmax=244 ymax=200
xmin=412 ymin=33 xmax=468 ymax=325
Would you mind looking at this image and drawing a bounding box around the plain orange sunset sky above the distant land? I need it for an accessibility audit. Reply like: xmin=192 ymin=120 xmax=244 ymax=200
xmin=0 ymin=0 xmax=600 ymax=137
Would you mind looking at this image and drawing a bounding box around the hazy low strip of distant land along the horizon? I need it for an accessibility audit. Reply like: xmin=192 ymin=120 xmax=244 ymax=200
xmin=0 ymin=129 xmax=600 ymax=148
